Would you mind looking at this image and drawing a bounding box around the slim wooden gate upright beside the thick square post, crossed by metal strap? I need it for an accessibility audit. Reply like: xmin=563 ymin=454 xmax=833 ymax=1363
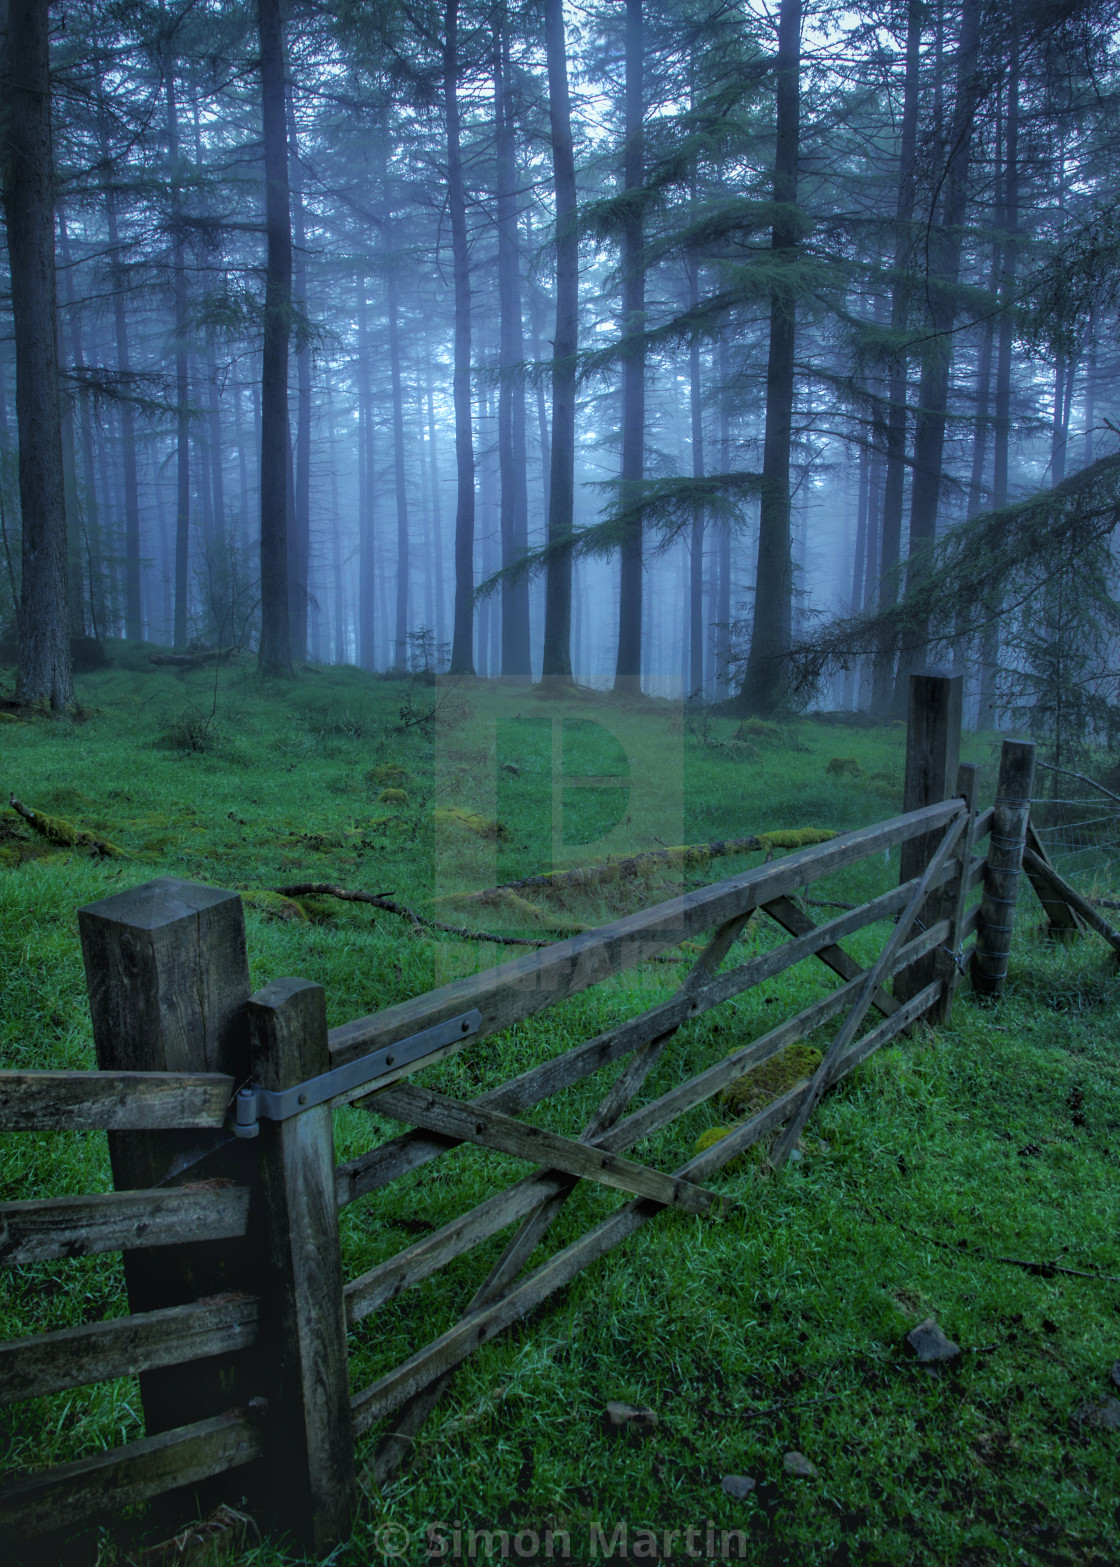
xmin=249 ymin=979 xmax=356 ymax=1556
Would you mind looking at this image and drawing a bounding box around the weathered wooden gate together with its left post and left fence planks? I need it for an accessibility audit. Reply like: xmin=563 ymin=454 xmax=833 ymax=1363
xmin=0 ymin=676 xmax=1032 ymax=1550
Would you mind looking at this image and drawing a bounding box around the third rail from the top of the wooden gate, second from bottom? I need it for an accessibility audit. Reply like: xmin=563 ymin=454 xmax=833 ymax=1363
xmin=346 ymin=920 xmax=949 ymax=1324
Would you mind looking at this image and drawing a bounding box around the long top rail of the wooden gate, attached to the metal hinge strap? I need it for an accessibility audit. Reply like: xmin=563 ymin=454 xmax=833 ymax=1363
xmin=331 ymin=801 xmax=960 ymax=1075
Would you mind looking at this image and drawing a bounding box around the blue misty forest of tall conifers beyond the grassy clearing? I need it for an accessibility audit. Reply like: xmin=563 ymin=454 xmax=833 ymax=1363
xmin=0 ymin=0 xmax=1120 ymax=754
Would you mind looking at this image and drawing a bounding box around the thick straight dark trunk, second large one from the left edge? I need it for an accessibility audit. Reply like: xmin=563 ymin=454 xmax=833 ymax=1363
xmin=257 ymin=0 xmax=291 ymax=675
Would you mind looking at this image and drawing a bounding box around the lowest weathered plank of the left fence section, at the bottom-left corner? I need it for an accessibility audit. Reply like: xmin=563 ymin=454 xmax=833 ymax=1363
xmin=0 ymin=1410 xmax=262 ymax=1540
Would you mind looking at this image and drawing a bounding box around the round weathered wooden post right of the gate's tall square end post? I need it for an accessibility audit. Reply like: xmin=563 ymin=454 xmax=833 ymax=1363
xmin=973 ymin=740 xmax=1035 ymax=1000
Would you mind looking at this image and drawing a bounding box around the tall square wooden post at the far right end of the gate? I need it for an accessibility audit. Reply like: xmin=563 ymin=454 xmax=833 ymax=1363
xmin=894 ymin=669 xmax=963 ymax=1001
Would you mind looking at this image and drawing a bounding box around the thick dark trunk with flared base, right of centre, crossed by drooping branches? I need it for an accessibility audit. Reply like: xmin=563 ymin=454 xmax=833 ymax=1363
xmin=738 ymin=0 xmax=800 ymax=713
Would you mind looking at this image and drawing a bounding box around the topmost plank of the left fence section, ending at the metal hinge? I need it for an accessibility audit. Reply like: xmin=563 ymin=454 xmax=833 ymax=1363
xmin=0 ymin=1072 xmax=233 ymax=1131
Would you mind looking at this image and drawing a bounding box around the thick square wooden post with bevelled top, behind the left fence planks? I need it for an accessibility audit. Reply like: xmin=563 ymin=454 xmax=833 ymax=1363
xmin=78 ymin=878 xmax=255 ymax=1447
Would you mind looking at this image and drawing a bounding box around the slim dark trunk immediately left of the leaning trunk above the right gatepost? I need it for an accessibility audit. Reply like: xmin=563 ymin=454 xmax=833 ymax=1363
xmin=868 ymin=0 xmax=924 ymax=716
